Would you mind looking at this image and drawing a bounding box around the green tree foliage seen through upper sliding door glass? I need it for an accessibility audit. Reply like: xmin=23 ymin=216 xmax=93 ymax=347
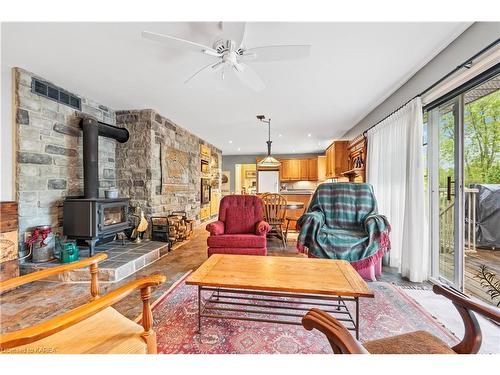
xmin=439 ymin=90 xmax=500 ymax=187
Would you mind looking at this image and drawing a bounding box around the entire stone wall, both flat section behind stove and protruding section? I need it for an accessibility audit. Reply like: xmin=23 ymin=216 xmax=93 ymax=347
xmin=14 ymin=68 xmax=221 ymax=253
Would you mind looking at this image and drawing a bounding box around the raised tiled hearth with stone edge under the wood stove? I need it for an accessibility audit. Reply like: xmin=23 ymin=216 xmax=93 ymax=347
xmin=20 ymin=241 xmax=168 ymax=283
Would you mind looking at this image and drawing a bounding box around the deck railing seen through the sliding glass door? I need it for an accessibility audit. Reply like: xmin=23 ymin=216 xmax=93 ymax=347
xmin=439 ymin=188 xmax=479 ymax=254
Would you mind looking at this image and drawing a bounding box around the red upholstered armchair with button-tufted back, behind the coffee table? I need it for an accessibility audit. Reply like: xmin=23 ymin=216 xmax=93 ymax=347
xmin=207 ymin=195 xmax=271 ymax=256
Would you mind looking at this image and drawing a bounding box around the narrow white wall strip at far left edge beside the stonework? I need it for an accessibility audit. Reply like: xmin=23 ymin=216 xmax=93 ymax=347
xmin=0 ymin=60 xmax=15 ymax=201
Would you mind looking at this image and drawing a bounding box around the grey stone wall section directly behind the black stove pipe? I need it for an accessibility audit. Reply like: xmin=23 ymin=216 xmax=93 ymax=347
xmin=15 ymin=68 xmax=116 ymax=241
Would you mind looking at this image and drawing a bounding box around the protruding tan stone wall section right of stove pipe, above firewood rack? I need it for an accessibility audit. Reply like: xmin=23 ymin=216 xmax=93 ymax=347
xmin=116 ymin=109 xmax=222 ymax=225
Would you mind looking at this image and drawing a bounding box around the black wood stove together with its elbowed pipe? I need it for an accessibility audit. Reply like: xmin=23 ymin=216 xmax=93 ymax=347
xmin=63 ymin=117 xmax=130 ymax=256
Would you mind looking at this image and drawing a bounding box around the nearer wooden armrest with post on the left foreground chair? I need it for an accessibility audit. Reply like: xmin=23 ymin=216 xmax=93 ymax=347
xmin=0 ymin=275 xmax=166 ymax=350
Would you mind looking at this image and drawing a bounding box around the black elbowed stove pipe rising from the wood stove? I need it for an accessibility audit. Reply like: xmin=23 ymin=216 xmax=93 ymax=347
xmin=80 ymin=117 xmax=129 ymax=199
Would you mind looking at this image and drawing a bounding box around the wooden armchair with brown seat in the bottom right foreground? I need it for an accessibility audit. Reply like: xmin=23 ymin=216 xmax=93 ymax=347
xmin=302 ymin=285 xmax=500 ymax=354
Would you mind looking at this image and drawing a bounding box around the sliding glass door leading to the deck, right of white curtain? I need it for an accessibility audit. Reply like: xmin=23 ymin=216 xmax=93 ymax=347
xmin=426 ymin=72 xmax=500 ymax=304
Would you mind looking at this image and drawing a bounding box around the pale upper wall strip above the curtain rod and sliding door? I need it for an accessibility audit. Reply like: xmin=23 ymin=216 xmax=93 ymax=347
xmin=343 ymin=22 xmax=500 ymax=139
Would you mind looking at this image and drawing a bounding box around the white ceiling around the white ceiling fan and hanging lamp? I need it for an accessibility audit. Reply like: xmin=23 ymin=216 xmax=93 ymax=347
xmin=2 ymin=22 xmax=469 ymax=155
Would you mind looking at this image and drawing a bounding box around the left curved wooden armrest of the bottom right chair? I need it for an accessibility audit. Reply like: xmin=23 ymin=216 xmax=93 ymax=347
xmin=302 ymin=308 xmax=368 ymax=354
